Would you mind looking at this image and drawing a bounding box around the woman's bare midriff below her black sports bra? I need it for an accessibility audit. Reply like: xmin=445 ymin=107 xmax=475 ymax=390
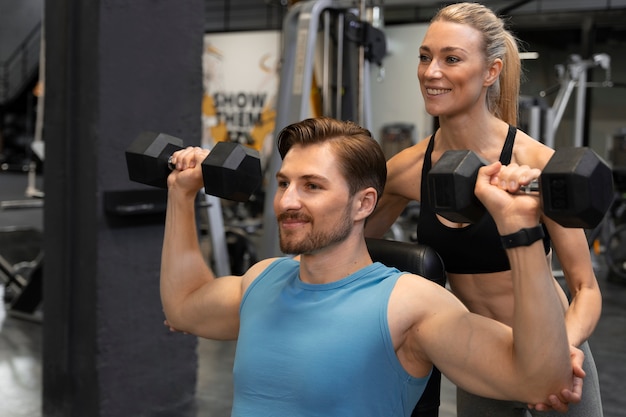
xmin=448 ymin=264 xmax=567 ymax=326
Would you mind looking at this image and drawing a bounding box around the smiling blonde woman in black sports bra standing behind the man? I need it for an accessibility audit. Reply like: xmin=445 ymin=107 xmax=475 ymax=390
xmin=366 ymin=3 xmax=602 ymax=417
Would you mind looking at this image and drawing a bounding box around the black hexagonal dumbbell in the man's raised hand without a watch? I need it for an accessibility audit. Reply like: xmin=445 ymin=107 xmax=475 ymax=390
xmin=126 ymin=132 xmax=262 ymax=202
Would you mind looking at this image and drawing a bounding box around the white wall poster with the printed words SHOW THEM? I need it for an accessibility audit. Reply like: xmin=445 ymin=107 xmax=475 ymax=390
xmin=202 ymin=31 xmax=280 ymax=162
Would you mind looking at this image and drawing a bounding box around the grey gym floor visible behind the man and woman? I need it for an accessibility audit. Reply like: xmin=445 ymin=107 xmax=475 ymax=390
xmin=0 ymin=171 xmax=626 ymax=417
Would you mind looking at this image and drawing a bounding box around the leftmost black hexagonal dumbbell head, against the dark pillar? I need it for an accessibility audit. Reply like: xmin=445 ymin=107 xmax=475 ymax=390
xmin=126 ymin=132 xmax=183 ymax=188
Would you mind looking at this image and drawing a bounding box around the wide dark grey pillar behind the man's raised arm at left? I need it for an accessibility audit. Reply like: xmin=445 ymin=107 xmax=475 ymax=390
xmin=43 ymin=0 xmax=204 ymax=417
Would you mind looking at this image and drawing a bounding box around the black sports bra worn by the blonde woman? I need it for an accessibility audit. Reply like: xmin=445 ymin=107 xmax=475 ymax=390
xmin=417 ymin=126 xmax=550 ymax=274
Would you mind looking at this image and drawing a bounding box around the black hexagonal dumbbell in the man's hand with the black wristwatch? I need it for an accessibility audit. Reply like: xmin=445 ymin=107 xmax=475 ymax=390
xmin=428 ymin=147 xmax=614 ymax=229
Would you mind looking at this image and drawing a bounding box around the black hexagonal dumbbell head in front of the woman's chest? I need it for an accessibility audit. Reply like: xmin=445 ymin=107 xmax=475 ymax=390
xmin=428 ymin=150 xmax=486 ymax=223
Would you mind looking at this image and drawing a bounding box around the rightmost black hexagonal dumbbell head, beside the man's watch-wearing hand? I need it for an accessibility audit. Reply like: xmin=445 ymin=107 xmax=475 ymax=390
xmin=539 ymin=147 xmax=614 ymax=229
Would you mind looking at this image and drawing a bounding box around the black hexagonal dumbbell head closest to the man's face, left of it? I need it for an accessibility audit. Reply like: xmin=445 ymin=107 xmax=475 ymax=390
xmin=202 ymin=142 xmax=262 ymax=202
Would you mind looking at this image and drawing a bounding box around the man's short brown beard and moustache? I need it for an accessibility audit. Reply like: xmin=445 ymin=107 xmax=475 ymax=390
xmin=278 ymin=206 xmax=354 ymax=255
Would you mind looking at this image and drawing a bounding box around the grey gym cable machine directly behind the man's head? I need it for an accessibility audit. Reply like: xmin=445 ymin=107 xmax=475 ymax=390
xmin=260 ymin=0 xmax=386 ymax=258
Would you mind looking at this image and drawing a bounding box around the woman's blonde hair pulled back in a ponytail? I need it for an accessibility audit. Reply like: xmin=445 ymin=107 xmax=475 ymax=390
xmin=431 ymin=3 xmax=521 ymax=126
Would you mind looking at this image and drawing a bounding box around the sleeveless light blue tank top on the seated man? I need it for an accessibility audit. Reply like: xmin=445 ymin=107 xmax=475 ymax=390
xmin=232 ymin=258 xmax=428 ymax=417
